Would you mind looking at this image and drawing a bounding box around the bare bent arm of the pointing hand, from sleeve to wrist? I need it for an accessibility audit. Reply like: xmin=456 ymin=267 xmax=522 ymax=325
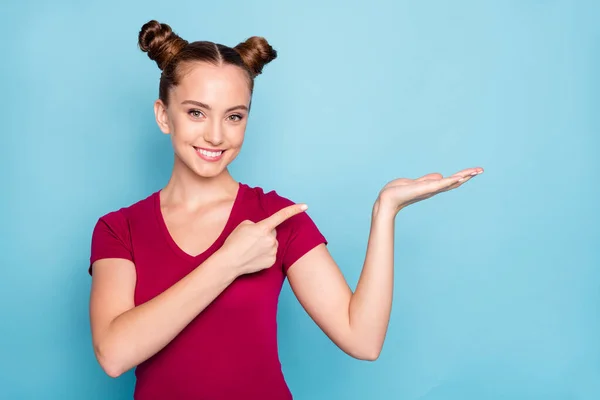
xmin=90 ymin=252 xmax=236 ymax=377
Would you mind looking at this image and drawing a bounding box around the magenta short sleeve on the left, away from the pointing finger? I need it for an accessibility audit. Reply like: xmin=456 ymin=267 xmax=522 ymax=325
xmin=88 ymin=210 xmax=133 ymax=275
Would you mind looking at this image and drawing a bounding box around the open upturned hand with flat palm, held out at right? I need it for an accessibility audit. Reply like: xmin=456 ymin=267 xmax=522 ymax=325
xmin=375 ymin=167 xmax=483 ymax=215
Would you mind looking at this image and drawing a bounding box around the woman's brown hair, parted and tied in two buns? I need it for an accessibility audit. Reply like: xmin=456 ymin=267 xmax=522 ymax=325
xmin=138 ymin=20 xmax=277 ymax=105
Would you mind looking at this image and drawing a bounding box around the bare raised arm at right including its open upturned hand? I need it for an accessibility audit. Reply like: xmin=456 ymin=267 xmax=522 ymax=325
xmin=287 ymin=168 xmax=483 ymax=361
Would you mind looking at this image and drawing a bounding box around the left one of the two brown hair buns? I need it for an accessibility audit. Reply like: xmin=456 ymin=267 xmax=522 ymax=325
xmin=138 ymin=20 xmax=188 ymax=70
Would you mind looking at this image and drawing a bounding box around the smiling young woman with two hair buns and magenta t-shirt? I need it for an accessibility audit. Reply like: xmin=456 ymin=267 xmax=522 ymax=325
xmin=89 ymin=21 xmax=483 ymax=400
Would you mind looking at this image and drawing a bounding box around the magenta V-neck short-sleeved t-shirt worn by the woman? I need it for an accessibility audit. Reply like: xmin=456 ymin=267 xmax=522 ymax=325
xmin=90 ymin=183 xmax=327 ymax=400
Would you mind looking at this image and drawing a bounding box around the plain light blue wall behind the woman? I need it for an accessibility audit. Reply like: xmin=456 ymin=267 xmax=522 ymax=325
xmin=0 ymin=0 xmax=600 ymax=400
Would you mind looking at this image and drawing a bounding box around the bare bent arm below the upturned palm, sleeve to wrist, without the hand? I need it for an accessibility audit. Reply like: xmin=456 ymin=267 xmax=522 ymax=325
xmin=288 ymin=203 xmax=394 ymax=361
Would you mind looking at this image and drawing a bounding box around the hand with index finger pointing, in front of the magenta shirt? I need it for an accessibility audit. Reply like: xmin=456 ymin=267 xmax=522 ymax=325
xmin=218 ymin=204 xmax=307 ymax=276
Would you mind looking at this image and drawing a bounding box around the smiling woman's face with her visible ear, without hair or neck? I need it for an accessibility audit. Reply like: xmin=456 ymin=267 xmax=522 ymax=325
xmin=154 ymin=62 xmax=251 ymax=178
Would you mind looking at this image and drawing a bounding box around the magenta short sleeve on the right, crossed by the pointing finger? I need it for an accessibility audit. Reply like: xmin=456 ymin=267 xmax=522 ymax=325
xmin=266 ymin=191 xmax=327 ymax=273
